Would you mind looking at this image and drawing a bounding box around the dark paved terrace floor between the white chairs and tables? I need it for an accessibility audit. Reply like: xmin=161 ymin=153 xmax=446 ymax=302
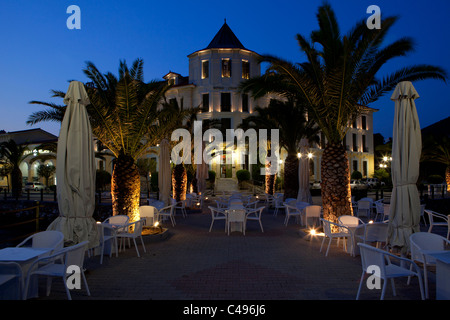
xmin=31 ymin=195 xmax=435 ymax=300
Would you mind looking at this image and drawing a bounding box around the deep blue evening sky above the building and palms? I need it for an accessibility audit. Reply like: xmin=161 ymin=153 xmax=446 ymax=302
xmin=0 ymin=0 xmax=450 ymax=138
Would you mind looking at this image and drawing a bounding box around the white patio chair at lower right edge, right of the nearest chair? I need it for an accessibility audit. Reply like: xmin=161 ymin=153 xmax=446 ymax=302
xmin=408 ymin=232 xmax=450 ymax=299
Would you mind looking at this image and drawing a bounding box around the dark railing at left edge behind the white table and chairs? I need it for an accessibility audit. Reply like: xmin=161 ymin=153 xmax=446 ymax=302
xmin=0 ymin=202 xmax=42 ymax=247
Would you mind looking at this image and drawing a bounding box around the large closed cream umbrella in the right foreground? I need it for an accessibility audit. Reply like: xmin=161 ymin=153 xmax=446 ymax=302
xmin=388 ymin=81 xmax=422 ymax=253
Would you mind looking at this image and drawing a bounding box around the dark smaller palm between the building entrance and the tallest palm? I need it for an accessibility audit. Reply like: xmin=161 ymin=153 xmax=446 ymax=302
xmin=241 ymin=98 xmax=319 ymax=198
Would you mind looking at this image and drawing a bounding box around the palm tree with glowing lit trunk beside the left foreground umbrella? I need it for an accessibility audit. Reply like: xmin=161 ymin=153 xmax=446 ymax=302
xmin=28 ymin=59 xmax=179 ymax=222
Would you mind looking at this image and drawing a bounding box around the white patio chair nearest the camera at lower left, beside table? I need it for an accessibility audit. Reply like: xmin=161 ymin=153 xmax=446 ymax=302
xmin=24 ymin=241 xmax=91 ymax=300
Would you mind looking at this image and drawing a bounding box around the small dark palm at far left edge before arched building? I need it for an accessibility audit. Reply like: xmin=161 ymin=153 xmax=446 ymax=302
xmin=0 ymin=139 xmax=28 ymax=199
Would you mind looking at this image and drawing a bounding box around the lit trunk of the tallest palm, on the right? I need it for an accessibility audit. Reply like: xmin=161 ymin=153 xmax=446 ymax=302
xmin=321 ymin=143 xmax=352 ymax=222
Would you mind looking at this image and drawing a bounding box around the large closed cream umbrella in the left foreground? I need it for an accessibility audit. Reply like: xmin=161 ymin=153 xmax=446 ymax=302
xmin=48 ymin=81 xmax=98 ymax=248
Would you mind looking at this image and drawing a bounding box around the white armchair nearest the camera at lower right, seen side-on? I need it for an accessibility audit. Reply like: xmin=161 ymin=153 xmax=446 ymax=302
xmin=356 ymin=243 xmax=424 ymax=300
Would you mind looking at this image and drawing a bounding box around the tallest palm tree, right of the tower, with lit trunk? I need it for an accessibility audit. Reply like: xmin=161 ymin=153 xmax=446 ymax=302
xmin=241 ymin=3 xmax=446 ymax=221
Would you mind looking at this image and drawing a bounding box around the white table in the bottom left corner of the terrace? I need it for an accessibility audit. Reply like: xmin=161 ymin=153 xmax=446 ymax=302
xmin=0 ymin=247 xmax=53 ymax=299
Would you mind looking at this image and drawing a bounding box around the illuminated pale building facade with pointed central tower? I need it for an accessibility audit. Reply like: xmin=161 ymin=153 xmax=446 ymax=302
xmin=163 ymin=22 xmax=376 ymax=181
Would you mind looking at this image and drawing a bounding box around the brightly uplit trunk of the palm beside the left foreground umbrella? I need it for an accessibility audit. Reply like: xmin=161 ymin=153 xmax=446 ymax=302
xmin=111 ymin=155 xmax=141 ymax=223
